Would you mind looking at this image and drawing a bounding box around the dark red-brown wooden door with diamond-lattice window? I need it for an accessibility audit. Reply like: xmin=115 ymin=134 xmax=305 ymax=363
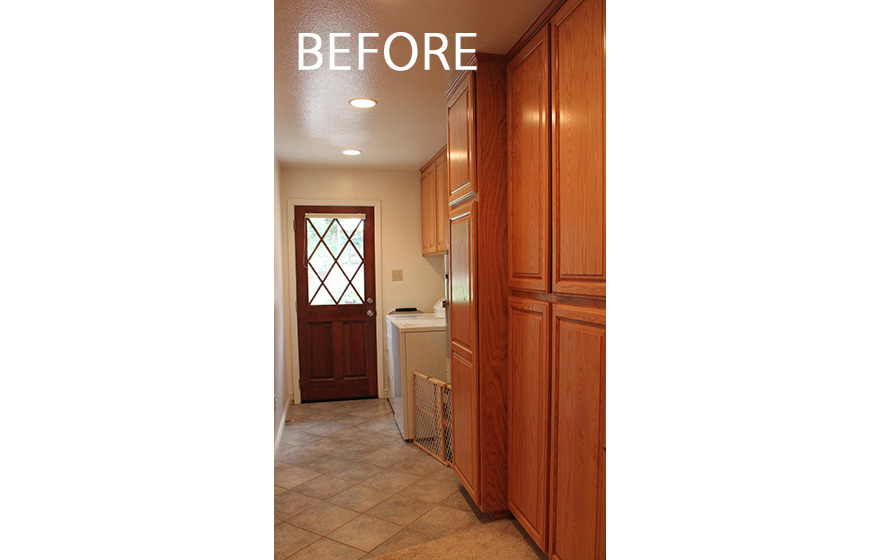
xmin=294 ymin=206 xmax=378 ymax=402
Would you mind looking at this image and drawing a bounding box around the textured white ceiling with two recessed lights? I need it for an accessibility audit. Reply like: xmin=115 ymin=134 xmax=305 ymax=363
xmin=275 ymin=0 xmax=549 ymax=169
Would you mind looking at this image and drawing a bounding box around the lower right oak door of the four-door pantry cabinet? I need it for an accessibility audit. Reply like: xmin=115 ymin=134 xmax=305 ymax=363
xmin=549 ymin=305 xmax=605 ymax=560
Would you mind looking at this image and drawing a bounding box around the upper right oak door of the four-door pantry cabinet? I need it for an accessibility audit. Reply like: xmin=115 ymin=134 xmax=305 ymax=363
xmin=550 ymin=0 xmax=605 ymax=297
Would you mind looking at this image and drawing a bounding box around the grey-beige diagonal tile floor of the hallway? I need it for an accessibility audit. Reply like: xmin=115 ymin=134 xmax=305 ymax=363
xmin=275 ymin=399 xmax=498 ymax=560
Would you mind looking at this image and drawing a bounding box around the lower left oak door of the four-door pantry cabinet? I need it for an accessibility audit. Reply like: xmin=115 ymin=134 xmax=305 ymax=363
xmin=507 ymin=297 xmax=550 ymax=552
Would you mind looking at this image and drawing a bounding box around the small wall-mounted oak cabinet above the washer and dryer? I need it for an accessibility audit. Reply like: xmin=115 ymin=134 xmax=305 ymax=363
xmin=421 ymin=146 xmax=449 ymax=256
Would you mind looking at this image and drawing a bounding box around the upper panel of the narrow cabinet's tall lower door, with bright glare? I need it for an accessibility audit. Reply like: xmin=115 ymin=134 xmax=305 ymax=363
xmin=449 ymin=201 xmax=477 ymax=356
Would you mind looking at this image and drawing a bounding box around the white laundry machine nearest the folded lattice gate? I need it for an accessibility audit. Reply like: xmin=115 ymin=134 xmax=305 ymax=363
xmin=385 ymin=313 xmax=449 ymax=440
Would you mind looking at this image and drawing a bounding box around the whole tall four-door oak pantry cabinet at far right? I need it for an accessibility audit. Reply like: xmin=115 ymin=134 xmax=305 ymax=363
xmin=507 ymin=0 xmax=605 ymax=560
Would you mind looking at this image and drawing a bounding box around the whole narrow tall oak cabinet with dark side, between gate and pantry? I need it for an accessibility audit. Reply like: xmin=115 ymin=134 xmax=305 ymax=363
xmin=446 ymin=53 xmax=508 ymax=514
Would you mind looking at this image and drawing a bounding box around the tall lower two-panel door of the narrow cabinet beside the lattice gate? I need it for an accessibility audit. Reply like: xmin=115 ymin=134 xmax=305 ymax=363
xmin=449 ymin=201 xmax=480 ymax=498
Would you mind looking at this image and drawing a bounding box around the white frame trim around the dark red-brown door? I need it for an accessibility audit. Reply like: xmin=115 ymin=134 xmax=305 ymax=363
xmin=285 ymin=198 xmax=385 ymax=404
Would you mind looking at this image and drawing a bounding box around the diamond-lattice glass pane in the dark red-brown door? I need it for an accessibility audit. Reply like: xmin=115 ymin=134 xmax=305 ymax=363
xmin=306 ymin=215 xmax=364 ymax=305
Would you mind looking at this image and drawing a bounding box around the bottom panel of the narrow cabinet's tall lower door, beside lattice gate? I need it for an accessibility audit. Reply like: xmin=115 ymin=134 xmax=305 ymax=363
xmin=450 ymin=352 xmax=480 ymax=498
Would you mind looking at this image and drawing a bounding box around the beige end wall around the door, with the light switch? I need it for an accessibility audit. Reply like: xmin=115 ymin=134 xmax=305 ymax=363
xmin=281 ymin=167 xmax=444 ymax=401
